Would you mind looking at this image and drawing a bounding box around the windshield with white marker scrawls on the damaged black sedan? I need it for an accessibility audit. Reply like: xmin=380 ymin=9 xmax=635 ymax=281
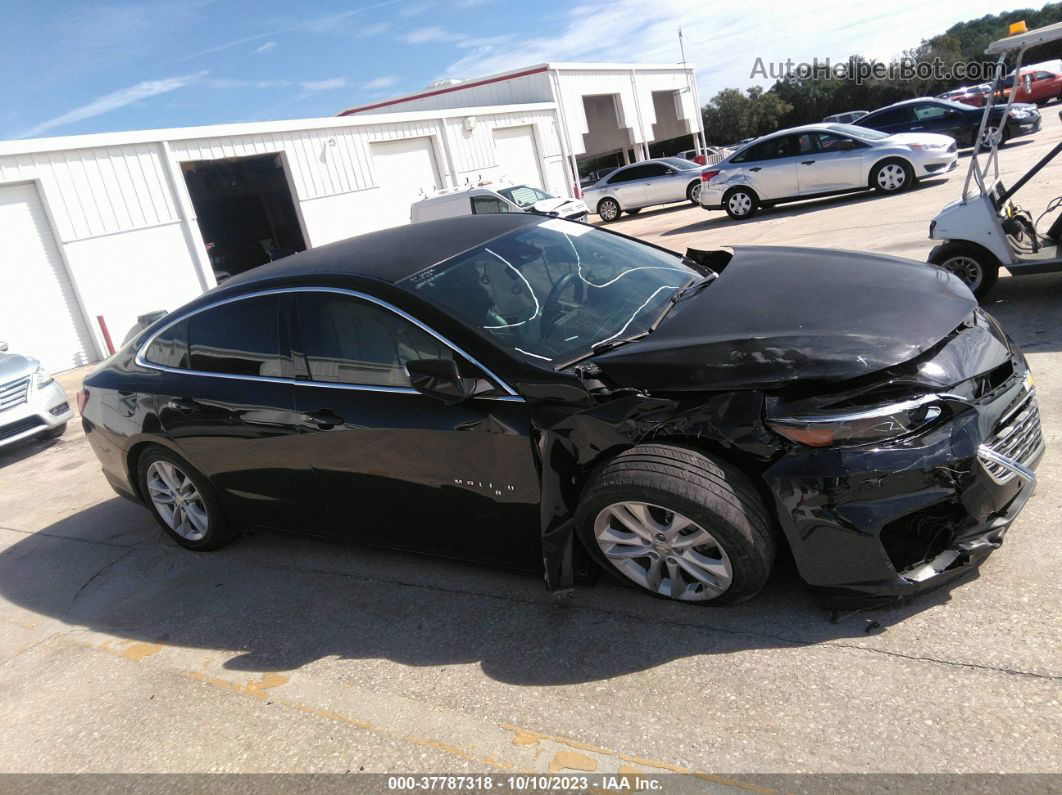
xmin=400 ymin=219 xmax=705 ymax=367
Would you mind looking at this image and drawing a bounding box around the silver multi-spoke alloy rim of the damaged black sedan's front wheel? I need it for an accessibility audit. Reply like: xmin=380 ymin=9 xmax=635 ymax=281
xmin=594 ymin=502 xmax=734 ymax=602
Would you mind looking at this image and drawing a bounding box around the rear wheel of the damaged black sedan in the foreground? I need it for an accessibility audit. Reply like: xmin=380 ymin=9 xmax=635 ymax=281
xmin=137 ymin=447 xmax=236 ymax=550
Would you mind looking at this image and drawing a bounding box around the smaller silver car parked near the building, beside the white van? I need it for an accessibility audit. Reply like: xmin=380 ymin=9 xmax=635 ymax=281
xmin=583 ymin=157 xmax=705 ymax=221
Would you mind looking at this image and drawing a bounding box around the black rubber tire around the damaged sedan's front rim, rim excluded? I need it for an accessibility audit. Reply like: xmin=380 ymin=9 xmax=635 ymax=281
xmin=576 ymin=444 xmax=776 ymax=605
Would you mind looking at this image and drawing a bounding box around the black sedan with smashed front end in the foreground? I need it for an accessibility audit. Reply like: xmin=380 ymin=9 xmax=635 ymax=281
xmin=80 ymin=213 xmax=1043 ymax=604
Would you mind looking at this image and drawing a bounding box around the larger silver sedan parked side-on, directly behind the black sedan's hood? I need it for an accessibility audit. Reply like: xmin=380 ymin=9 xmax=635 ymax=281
xmin=700 ymin=124 xmax=959 ymax=219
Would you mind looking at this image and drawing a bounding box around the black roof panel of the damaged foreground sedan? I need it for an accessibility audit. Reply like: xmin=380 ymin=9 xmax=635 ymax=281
xmin=222 ymin=212 xmax=549 ymax=289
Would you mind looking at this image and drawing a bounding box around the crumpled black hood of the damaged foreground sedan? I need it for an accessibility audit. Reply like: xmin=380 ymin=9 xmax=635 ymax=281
xmin=594 ymin=246 xmax=977 ymax=391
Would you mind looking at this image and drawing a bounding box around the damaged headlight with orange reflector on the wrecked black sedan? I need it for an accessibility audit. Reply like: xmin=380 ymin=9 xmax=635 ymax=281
xmin=767 ymin=395 xmax=942 ymax=447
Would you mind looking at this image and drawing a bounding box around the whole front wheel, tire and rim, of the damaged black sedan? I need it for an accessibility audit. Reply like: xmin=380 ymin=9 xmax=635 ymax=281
xmin=576 ymin=445 xmax=775 ymax=605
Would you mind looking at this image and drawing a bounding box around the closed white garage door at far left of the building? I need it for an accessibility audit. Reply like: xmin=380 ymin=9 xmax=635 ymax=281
xmin=0 ymin=183 xmax=96 ymax=371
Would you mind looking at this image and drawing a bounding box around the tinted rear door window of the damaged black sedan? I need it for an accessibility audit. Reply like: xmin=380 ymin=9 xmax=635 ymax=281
xmin=188 ymin=295 xmax=292 ymax=378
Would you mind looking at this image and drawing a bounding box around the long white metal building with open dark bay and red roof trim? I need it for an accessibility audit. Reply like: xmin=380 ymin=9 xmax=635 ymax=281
xmin=0 ymin=66 xmax=700 ymax=370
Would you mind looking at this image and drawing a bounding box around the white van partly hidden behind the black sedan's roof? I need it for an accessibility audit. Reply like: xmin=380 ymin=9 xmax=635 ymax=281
xmin=409 ymin=185 xmax=589 ymax=224
